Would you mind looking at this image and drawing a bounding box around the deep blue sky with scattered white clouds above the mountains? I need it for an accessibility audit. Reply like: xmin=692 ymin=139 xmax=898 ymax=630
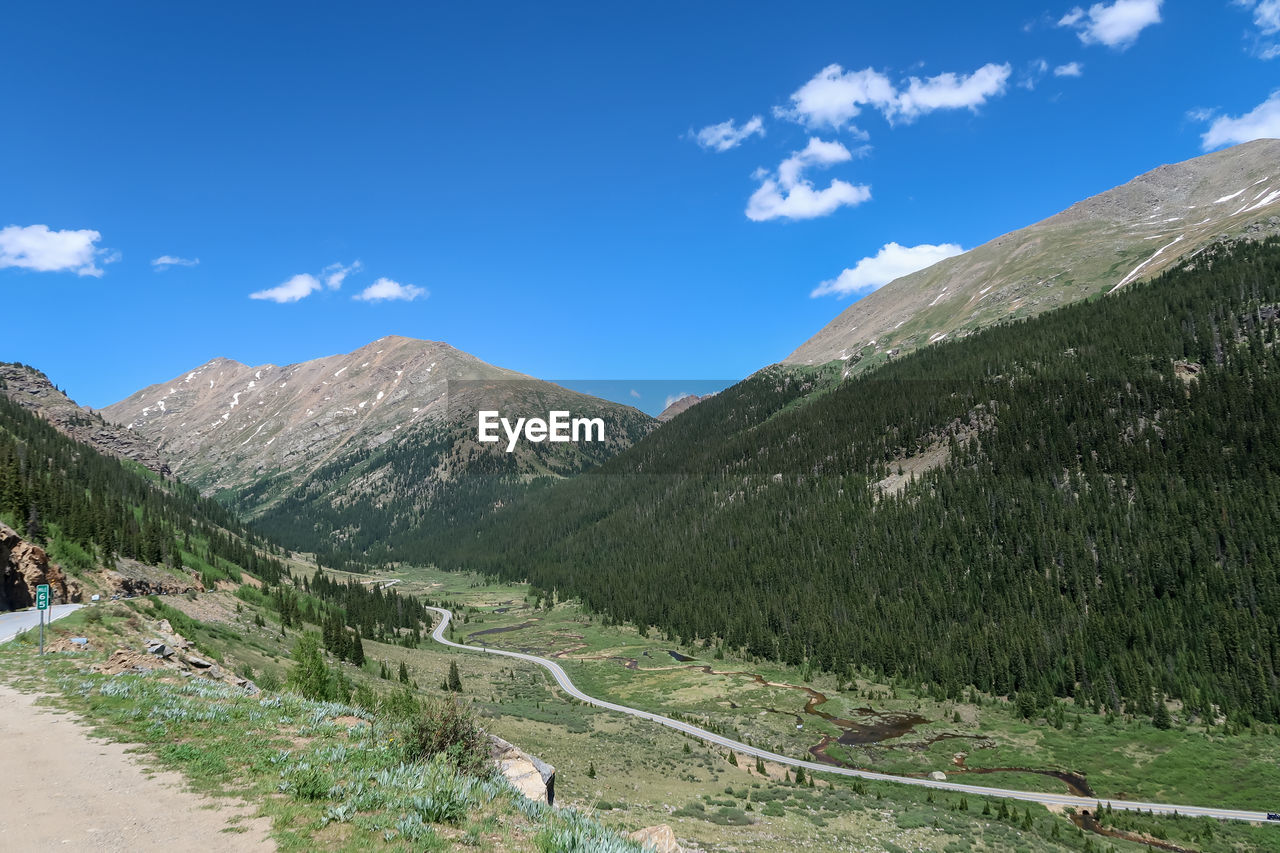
xmin=0 ymin=0 xmax=1280 ymax=410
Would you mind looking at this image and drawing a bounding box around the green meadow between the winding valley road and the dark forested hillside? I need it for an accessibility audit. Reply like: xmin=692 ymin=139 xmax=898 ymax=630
xmin=416 ymin=570 xmax=1280 ymax=811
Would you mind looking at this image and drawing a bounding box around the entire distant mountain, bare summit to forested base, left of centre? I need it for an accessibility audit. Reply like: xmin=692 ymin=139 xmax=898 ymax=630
xmin=104 ymin=337 xmax=655 ymax=557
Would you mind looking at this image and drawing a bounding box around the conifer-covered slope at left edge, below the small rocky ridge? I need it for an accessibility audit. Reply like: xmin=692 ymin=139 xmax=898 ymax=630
xmin=0 ymin=379 xmax=283 ymax=610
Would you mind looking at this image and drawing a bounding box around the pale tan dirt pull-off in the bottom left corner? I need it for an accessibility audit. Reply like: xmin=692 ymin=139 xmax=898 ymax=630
xmin=0 ymin=684 xmax=275 ymax=853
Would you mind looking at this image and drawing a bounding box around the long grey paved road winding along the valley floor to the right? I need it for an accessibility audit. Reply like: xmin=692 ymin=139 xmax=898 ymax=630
xmin=428 ymin=607 xmax=1267 ymax=822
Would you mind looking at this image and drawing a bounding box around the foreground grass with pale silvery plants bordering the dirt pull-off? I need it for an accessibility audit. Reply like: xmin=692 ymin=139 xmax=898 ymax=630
xmin=0 ymin=607 xmax=639 ymax=852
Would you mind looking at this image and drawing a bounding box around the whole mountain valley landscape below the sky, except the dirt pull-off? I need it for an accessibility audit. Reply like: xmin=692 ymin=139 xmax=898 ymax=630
xmin=0 ymin=134 xmax=1280 ymax=853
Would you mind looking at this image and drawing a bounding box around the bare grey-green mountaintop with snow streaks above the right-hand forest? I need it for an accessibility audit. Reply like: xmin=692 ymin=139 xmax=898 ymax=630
xmin=786 ymin=140 xmax=1280 ymax=371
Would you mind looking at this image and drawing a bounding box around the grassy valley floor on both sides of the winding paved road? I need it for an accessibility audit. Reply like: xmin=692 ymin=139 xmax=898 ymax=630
xmin=348 ymin=569 xmax=1280 ymax=850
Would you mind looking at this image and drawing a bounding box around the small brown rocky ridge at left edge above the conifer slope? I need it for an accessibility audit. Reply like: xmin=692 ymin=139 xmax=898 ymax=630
xmin=0 ymin=364 xmax=172 ymax=476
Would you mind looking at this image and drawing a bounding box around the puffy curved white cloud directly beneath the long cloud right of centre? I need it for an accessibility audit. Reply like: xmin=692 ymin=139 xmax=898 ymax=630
xmin=746 ymin=137 xmax=872 ymax=222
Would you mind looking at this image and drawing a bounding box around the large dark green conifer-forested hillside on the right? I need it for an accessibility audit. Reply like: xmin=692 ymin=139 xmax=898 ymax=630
xmin=427 ymin=235 xmax=1280 ymax=721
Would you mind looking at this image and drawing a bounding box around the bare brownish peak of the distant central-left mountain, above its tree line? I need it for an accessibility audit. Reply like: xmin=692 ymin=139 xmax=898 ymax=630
xmin=102 ymin=336 xmax=652 ymax=512
